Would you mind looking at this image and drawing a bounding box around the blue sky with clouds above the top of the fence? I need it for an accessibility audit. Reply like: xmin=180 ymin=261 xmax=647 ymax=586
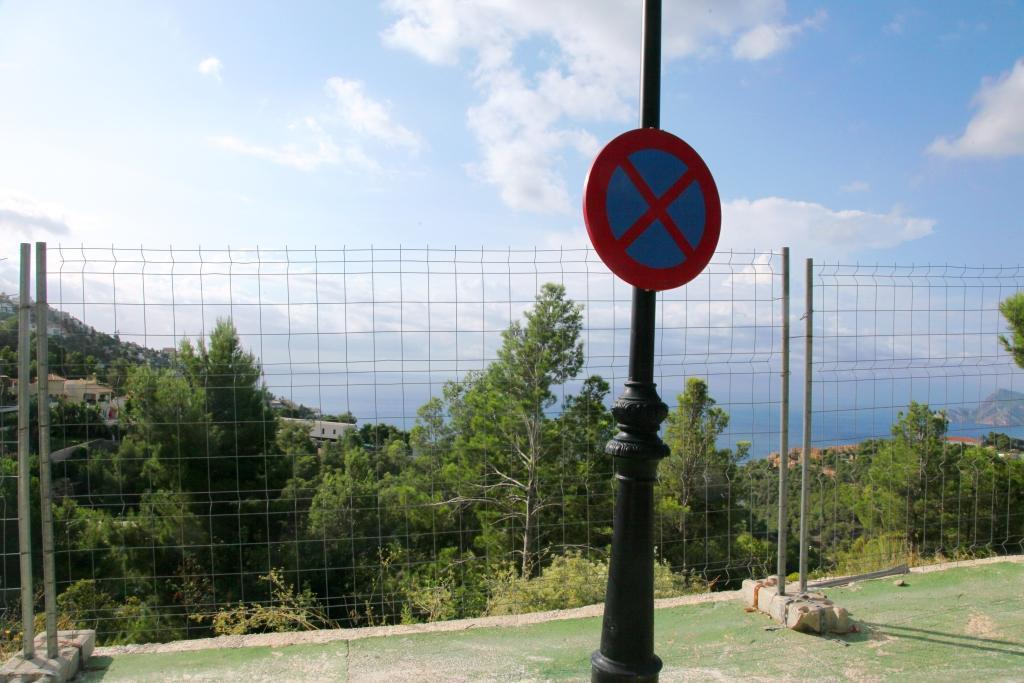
xmin=0 ymin=0 xmax=1024 ymax=281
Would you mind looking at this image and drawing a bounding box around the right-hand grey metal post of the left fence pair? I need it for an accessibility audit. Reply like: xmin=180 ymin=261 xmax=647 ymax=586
xmin=36 ymin=242 xmax=58 ymax=659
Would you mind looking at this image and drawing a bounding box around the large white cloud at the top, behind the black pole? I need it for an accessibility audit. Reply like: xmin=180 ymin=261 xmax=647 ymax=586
xmin=382 ymin=0 xmax=818 ymax=214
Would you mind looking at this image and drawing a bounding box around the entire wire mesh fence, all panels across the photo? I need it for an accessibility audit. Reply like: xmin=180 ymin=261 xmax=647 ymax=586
xmin=0 ymin=247 xmax=1024 ymax=642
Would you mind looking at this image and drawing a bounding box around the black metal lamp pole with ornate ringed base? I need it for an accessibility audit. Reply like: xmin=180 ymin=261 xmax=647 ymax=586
xmin=590 ymin=0 xmax=669 ymax=682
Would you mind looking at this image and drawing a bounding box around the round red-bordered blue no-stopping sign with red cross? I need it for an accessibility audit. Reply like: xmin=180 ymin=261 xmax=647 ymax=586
xmin=584 ymin=128 xmax=721 ymax=290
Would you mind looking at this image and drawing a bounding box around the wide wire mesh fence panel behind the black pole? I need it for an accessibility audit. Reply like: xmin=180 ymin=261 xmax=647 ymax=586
xmin=0 ymin=247 xmax=780 ymax=641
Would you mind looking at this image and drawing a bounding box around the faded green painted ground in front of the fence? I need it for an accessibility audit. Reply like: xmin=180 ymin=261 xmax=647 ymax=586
xmin=81 ymin=563 xmax=1024 ymax=683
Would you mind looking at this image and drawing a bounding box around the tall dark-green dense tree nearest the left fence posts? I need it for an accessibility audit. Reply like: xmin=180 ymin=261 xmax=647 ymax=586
xmin=116 ymin=321 xmax=294 ymax=614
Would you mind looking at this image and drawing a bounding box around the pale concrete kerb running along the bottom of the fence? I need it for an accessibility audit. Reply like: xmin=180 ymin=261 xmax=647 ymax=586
xmin=86 ymin=555 xmax=1024 ymax=656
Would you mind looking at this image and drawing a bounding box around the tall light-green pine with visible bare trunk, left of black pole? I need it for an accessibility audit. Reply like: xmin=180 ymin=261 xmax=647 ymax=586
xmin=445 ymin=283 xmax=584 ymax=575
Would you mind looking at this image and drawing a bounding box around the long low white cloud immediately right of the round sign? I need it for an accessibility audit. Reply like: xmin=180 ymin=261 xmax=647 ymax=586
xmin=719 ymin=197 xmax=935 ymax=257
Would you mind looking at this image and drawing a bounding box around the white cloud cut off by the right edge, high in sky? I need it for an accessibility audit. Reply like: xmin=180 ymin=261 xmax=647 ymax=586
xmin=928 ymin=58 xmax=1024 ymax=158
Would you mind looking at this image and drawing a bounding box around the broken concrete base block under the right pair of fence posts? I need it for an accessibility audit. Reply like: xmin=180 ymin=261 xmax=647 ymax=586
xmin=740 ymin=578 xmax=854 ymax=634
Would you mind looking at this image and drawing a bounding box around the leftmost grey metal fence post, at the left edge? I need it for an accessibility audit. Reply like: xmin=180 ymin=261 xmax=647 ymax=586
xmin=17 ymin=243 xmax=36 ymax=659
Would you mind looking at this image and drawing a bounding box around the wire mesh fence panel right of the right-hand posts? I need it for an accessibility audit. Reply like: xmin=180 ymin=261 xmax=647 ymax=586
xmin=809 ymin=260 xmax=1024 ymax=573
